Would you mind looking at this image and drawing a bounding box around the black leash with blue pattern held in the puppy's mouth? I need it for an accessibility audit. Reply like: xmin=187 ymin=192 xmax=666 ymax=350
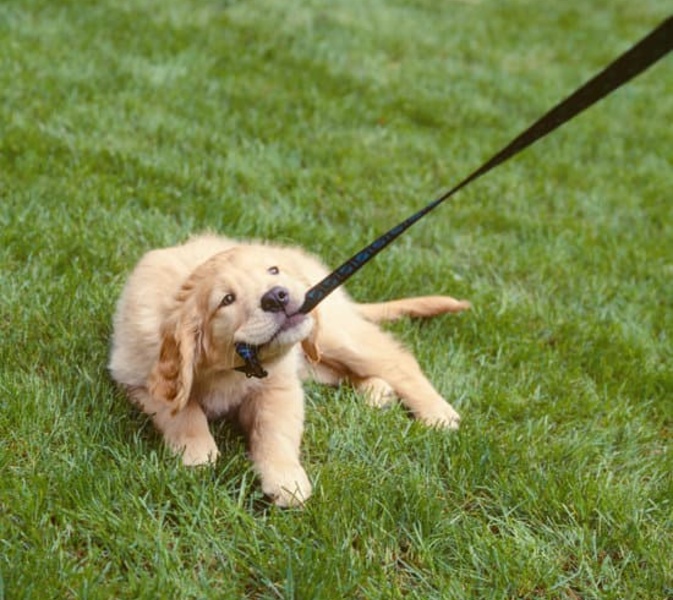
xmin=236 ymin=16 xmax=673 ymax=377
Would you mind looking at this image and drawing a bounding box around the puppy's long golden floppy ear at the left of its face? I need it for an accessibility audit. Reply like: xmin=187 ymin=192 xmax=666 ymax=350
xmin=149 ymin=288 xmax=202 ymax=413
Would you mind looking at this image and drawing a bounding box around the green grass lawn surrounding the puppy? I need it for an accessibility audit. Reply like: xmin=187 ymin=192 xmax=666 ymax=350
xmin=0 ymin=0 xmax=673 ymax=600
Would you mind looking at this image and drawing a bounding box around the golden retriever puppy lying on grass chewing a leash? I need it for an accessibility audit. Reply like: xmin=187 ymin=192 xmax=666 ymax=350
xmin=109 ymin=235 xmax=469 ymax=506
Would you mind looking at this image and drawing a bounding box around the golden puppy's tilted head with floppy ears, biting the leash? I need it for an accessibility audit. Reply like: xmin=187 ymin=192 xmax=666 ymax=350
xmin=150 ymin=245 xmax=315 ymax=410
